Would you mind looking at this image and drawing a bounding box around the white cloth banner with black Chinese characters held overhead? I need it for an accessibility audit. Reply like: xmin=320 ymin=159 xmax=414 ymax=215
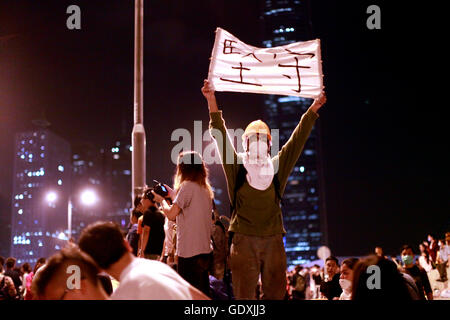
xmin=208 ymin=28 xmax=323 ymax=98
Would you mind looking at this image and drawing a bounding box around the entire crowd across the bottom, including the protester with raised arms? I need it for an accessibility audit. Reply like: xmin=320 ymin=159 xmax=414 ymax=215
xmin=0 ymin=80 xmax=450 ymax=300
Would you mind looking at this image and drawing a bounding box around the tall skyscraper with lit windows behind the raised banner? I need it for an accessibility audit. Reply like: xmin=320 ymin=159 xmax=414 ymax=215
xmin=261 ymin=0 xmax=327 ymax=266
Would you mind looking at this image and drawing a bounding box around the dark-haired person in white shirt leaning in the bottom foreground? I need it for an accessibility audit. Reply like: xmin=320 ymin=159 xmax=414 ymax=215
xmin=79 ymin=222 xmax=208 ymax=300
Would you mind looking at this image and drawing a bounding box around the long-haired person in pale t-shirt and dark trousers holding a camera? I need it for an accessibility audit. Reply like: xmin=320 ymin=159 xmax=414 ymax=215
xmin=152 ymin=151 xmax=214 ymax=296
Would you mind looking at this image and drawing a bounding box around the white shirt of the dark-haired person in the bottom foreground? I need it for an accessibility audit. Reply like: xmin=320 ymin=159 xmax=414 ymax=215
xmin=111 ymin=258 xmax=192 ymax=300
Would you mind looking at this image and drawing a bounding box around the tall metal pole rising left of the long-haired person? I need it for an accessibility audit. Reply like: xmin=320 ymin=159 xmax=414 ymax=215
xmin=131 ymin=0 xmax=146 ymax=199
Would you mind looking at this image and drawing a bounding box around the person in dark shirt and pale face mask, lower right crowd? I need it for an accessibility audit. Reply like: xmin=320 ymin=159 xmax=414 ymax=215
xmin=401 ymin=245 xmax=433 ymax=300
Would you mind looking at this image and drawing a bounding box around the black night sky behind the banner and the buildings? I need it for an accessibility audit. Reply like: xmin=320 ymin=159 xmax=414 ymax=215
xmin=0 ymin=0 xmax=450 ymax=255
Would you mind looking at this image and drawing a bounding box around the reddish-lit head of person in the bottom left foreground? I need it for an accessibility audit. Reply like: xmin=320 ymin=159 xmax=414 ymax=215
xmin=31 ymin=244 xmax=108 ymax=300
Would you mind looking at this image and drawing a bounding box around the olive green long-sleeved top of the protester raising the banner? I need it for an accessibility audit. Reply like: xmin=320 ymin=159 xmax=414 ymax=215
xmin=210 ymin=108 xmax=319 ymax=236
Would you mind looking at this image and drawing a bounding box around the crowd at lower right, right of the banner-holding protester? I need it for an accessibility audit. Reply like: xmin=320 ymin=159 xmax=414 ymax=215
xmin=285 ymin=232 xmax=450 ymax=300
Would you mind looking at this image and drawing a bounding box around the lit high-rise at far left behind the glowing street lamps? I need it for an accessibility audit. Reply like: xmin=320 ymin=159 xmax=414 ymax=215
xmin=10 ymin=128 xmax=71 ymax=263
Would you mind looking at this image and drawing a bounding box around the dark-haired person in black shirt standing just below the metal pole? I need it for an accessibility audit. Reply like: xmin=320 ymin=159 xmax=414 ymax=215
xmin=138 ymin=188 xmax=165 ymax=260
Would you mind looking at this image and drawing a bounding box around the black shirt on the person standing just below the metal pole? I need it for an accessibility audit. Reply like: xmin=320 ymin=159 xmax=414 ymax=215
xmin=142 ymin=207 xmax=165 ymax=255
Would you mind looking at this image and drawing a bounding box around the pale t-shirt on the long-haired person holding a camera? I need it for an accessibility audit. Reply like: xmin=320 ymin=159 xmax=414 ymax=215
xmin=174 ymin=181 xmax=213 ymax=258
